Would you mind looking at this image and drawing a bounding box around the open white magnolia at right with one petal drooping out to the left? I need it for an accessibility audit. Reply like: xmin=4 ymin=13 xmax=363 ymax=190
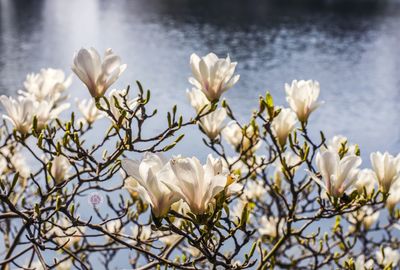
xmin=310 ymin=151 xmax=362 ymax=198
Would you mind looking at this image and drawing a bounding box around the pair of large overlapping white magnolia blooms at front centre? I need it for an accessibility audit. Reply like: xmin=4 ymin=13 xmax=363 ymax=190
xmin=122 ymin=153 xmax=234 ymax=217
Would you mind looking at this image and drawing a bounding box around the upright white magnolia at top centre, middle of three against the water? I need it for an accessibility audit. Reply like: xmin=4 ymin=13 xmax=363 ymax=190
xmin=189 ymin=53 xmax=239 ymax=101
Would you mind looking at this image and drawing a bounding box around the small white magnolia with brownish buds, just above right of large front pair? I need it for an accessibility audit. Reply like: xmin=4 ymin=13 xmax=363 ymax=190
xmin=222 ymin=121 xmax=261 ymax=152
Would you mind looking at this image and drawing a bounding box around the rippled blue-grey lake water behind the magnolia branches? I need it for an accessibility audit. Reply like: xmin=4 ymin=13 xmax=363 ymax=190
xmin=0 ymin=0 xmax=400 ymax=160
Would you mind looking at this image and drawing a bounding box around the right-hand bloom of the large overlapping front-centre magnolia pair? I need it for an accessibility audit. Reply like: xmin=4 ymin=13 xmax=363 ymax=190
xmin=164 ymin=155 xmax=228 ymax=214
